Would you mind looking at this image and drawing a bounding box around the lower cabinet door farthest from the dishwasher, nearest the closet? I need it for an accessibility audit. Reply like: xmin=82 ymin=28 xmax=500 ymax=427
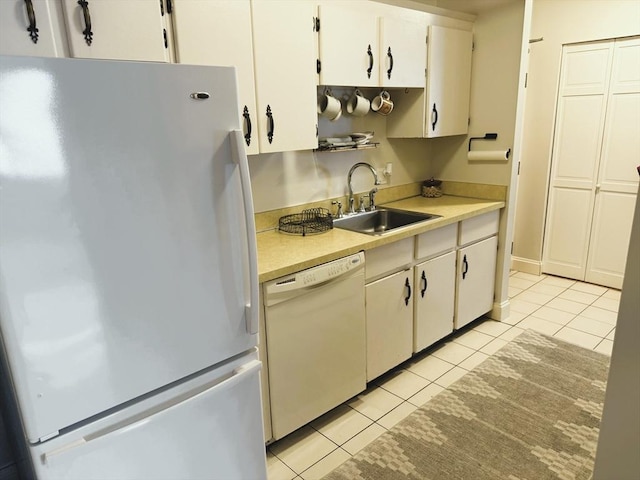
xmin=455 ymin=236 xmax=498 ymax=329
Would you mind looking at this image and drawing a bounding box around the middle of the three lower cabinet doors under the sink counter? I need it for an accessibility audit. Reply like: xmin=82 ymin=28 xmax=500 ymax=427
xmin=413 ymin=252 xmax=456 ymax=352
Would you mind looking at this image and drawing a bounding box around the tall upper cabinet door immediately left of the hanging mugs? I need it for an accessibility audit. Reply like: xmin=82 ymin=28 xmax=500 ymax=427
xmin=251 ymin=0 xmax=318 ymax=153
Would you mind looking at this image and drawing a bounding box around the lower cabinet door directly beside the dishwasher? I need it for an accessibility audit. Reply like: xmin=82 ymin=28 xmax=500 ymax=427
xmin=365 ymin=270 xmax=415 ymax=382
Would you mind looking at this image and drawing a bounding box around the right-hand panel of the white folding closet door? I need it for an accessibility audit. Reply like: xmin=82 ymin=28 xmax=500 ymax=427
xmin=585 ymin=37 xmax=640 ymax=288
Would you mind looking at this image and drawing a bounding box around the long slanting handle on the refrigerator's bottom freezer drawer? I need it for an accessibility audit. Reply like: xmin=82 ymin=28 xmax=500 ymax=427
xmin=42 ymin=360 xmax=262 ymax=465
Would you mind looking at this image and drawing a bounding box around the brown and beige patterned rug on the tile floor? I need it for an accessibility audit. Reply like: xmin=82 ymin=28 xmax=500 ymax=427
xmin=324 ymin=330 xmax=610 ymax=480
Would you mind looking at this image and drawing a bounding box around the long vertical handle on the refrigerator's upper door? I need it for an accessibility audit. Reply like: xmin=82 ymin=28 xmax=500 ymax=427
xmin=231 ymin=130 xmax=259 ymax=334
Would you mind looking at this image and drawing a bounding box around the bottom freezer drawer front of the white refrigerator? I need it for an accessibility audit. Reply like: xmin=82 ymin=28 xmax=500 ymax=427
xmin=32 ymin=355 xmax=266 ymax=480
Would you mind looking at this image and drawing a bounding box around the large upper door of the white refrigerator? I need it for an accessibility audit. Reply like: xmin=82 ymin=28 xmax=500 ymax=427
xmin=0 ymin=57 xmax=257 ymax=442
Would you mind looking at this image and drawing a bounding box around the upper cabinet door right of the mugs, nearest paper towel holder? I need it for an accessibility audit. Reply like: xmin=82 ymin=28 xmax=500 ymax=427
xmin=425 ymin=25 xmax=473 ymax=138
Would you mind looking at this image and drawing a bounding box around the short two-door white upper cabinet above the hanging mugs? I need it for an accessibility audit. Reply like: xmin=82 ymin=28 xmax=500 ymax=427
xmin=318 ymin=2 xmax=426 ymax=88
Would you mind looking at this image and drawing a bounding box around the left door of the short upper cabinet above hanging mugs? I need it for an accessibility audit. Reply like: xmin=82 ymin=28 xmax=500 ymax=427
xmin=319 ymin=4 xmax=380 ymax=87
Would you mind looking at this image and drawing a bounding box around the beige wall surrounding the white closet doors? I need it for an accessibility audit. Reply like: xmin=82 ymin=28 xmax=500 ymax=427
xmin=513 ymin=0 xmax=640 ymax=273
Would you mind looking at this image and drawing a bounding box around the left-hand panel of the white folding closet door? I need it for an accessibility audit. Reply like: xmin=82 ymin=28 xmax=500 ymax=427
xmin=542 ymin=42 xmax=613 ymax=279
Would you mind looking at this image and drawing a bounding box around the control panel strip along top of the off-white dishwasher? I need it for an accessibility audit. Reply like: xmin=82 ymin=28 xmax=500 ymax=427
xmin=266 ymin=252 xmax=364 ymax=294
